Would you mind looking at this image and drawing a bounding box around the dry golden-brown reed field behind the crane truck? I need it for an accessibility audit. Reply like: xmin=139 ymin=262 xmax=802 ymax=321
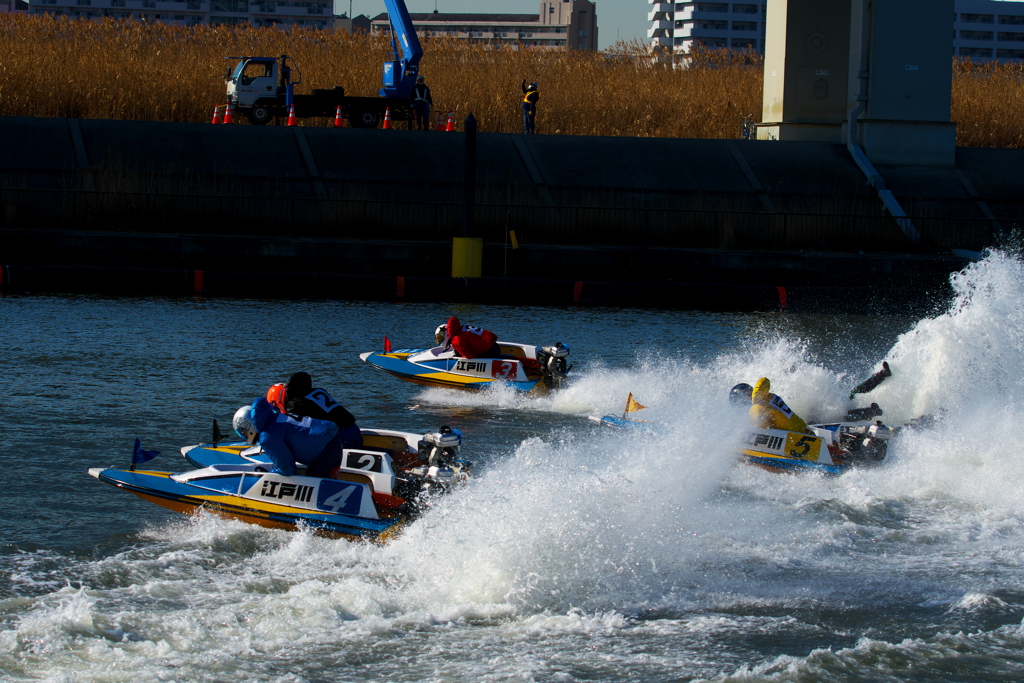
xmin=0 ymin=14 xmax=1024 ymax=147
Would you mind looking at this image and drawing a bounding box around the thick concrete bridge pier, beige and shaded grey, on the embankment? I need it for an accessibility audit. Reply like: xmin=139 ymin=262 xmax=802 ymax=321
xmin=758 ymin=0 xmax=956 ymax=166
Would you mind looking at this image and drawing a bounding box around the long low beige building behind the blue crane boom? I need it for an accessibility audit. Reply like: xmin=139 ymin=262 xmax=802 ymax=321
xmin=371 ymin=0 xmax=597 ymax=50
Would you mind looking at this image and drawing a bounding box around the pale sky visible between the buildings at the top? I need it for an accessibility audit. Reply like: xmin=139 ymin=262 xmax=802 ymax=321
xmin=344 ymin=0 xmax=650 ymax=50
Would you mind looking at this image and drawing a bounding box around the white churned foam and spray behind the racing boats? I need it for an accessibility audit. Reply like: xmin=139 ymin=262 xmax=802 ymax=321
xmin=6 ymin=253 xmax=1024 ymax=681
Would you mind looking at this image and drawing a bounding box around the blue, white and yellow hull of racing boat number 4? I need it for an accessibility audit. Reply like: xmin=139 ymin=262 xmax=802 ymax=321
xmin=89 ymin=465 xmax=404 ymax=541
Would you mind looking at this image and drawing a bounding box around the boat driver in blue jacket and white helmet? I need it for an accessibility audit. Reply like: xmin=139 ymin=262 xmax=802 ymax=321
xmin=231 ymin=397 xmax=344 ymax=477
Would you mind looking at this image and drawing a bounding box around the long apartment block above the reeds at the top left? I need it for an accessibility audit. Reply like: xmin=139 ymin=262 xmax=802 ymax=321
xmin=29 ymin=0 xmax=334 ymax=29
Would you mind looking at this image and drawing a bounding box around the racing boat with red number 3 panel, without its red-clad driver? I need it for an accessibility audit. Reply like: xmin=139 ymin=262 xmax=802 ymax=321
xmin=359 ymin=341 xmax=571 ymax=392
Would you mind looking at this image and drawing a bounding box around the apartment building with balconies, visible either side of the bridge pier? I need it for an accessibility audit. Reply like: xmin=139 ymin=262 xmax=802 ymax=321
xmin=647 ymin=0 xmax=1024 ymax=61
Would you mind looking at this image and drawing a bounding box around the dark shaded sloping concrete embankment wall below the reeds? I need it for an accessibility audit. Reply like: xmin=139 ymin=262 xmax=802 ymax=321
xmin=0 ymin=118 xmax=1024 ymax=305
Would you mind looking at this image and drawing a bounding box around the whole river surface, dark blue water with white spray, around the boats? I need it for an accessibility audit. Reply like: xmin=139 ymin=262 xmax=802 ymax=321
xmin=0 ymin=254 xmax=1024 ymax=683
